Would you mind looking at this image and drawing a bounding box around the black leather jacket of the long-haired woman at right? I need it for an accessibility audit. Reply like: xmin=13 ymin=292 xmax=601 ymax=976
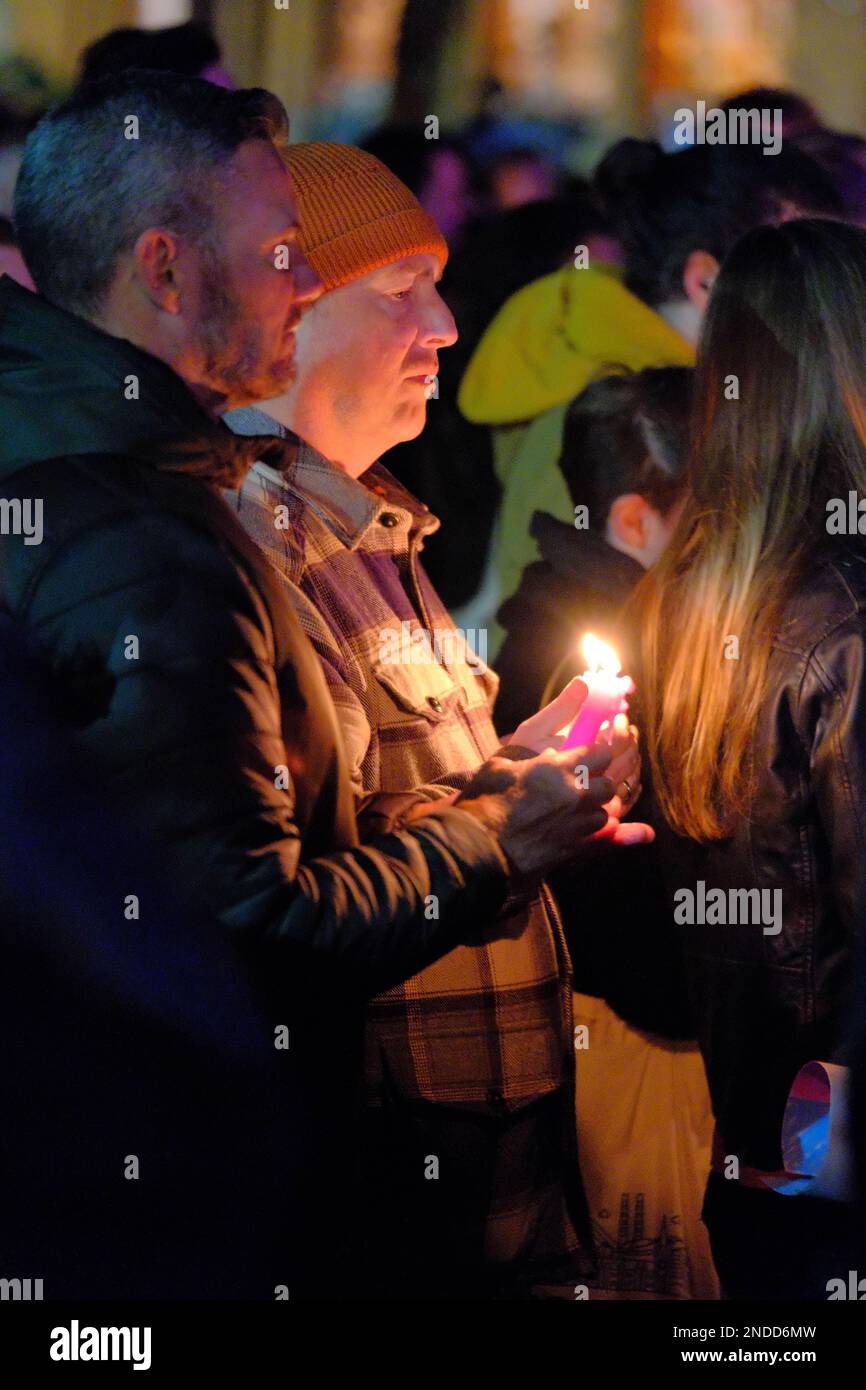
xmin=655 ymin=539 xmax=866 ymax=1169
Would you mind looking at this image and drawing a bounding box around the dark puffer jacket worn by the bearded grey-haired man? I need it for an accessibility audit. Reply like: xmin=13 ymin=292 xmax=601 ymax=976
xmin=0 ymin=278 xmax=506 ymax=1284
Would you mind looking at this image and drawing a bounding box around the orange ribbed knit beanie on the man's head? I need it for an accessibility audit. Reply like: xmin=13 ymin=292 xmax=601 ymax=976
xmin=285 ymin=140 xmax=448 ymax=291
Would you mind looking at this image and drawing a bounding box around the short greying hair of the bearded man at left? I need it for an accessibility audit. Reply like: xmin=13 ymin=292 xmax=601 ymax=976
xmin=13 ymin=70 xmax=288 ymax=317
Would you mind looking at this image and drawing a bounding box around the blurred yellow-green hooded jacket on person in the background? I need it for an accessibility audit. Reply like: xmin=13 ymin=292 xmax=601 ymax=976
xmin=457 ymin=265 xmax=694 ymax=652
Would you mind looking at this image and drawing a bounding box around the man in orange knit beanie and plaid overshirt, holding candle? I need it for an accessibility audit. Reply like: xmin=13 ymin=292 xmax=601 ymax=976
xmin=225 ymin=143 xmax=642 ymax=1298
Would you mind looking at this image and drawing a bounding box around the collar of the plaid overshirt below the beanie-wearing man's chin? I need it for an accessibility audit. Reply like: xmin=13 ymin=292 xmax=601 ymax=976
xmin=225 ymin=407 xmax=439 ymax=550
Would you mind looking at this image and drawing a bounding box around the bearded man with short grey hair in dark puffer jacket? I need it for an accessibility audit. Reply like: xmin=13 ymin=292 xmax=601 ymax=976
xmin=0 ymin=72 xmax=644 ymax=1297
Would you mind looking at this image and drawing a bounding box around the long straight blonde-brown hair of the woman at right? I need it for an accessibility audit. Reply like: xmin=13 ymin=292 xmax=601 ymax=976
xmin=632 ymin=220 xmax=866 ymax=841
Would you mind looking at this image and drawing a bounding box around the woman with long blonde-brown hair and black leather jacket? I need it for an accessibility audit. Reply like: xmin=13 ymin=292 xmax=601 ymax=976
xmin=635 ymin=211 xmax=866 ymax=1298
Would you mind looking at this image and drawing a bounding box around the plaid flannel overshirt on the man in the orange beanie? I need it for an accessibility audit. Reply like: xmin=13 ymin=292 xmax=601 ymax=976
xmin=227 ymin=409 xmax=574 ymax=1115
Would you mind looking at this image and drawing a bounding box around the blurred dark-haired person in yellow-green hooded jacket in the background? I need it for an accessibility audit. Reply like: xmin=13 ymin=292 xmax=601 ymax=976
xmin=457 ymin=139 xmax=840 ymax=644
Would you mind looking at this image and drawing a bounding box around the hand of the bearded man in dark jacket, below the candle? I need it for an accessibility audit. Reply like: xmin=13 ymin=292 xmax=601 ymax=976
xmin=456 ymin=744 xmax=653 ymax=874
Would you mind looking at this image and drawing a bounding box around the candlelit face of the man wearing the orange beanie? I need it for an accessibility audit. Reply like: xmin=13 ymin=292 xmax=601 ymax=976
xmin=284 ymin=253 xmax=457 ymax=477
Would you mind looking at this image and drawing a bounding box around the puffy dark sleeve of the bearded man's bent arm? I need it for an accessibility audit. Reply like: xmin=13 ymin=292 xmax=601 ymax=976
xmin=17 ymin=513 xmax=507 ymax=992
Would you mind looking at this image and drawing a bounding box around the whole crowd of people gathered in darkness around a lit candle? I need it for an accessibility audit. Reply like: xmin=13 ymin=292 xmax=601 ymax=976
xmin=0 ymin=22 xmax=866 ymax=1301
